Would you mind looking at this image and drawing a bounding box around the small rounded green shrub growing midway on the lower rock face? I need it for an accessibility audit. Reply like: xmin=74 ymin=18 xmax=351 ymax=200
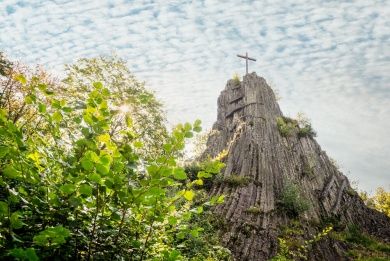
xmin=280 ymin=180 xmax=310 ymax=217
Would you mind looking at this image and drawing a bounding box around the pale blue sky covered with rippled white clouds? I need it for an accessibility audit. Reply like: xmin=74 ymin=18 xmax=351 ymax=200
xmin=0 ymin=0 xmax=390 ymax=192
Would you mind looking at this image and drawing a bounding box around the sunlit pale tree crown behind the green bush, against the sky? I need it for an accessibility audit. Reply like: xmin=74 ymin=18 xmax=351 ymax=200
xmin=64 ymin=56 xmax=168 ymax=156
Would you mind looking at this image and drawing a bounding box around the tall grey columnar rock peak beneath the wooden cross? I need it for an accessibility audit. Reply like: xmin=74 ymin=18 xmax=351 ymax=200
xmin=205 ymin=73 xmax=390 ymax=261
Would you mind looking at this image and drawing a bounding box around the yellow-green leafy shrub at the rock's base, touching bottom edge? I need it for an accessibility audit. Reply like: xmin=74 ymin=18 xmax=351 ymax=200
xmin=271 ymin=221 xmax=333 ymax=261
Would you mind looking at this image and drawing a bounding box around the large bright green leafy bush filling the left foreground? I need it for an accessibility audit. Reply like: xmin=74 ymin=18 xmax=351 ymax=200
xmin=0 ymin=72 xmax=223 ymax=260
